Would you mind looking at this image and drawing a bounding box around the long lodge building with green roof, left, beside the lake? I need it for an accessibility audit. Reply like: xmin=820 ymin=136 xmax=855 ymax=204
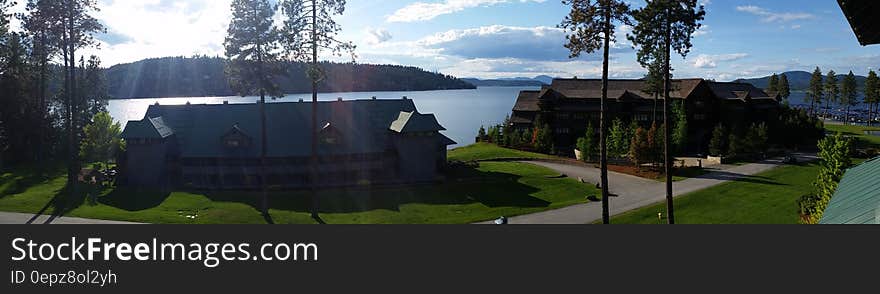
xmin=120 ymin=98 xmax=456 ymax=189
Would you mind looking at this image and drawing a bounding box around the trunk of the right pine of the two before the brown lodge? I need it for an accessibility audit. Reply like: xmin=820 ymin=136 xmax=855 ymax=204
xmin=663 ymin=10 xmax=675 ymax=225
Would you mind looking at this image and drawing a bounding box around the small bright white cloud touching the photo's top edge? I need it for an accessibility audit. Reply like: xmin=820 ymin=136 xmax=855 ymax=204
xmin=385 ymin=0 xmax=546 ymax=22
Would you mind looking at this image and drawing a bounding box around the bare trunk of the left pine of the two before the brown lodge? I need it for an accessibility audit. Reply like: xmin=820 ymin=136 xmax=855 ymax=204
xmin=599 ymin=4 xmax=611 ymax=224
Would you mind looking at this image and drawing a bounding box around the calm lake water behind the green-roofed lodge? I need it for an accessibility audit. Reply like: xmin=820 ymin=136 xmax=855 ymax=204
xmin=108 ymin=87 xmax=538 ymax=147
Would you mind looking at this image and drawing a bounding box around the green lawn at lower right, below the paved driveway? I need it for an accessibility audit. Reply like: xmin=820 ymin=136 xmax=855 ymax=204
xmin=612 ymin=164 xmax=819 ymax=224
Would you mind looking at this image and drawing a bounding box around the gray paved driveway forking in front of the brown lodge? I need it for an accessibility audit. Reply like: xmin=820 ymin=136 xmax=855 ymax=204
xmin=484 ymin=154 xmax=816 ymax=224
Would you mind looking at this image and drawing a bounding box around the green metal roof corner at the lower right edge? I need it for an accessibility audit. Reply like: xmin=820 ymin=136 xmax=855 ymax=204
xmin=819 ymin=157 xmax=880 ymax=224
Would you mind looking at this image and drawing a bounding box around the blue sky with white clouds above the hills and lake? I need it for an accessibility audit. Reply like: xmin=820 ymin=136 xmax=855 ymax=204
xmin=10 ymin=0 xmax=880 ymax=81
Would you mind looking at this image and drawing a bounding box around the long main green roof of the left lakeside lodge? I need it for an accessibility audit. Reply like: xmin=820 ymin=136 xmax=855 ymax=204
xmin=146 ymin=99 xmax=433 ymax=158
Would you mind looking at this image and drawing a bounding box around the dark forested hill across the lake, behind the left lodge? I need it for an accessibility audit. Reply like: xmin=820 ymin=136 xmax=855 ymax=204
xmin=107 ymin=57 xmax=474 ymax=99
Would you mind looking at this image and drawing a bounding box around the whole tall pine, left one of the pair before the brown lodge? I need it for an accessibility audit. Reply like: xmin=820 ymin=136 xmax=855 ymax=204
xmin=559 ymin=0 xmax=631 ymax=224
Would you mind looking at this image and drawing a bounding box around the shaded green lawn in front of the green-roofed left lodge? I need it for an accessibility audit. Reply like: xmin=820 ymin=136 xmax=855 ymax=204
xmin=0 ymin=162 xmax=597 ymax=224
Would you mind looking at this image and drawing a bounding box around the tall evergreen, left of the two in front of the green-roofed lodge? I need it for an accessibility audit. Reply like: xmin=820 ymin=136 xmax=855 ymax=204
xmin=224 ymin=0 xmax=282 ymax=217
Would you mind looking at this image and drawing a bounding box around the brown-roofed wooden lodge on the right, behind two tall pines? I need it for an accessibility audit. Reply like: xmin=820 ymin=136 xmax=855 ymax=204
xmin=510 ymin=78 xmax=781 ymax=153
